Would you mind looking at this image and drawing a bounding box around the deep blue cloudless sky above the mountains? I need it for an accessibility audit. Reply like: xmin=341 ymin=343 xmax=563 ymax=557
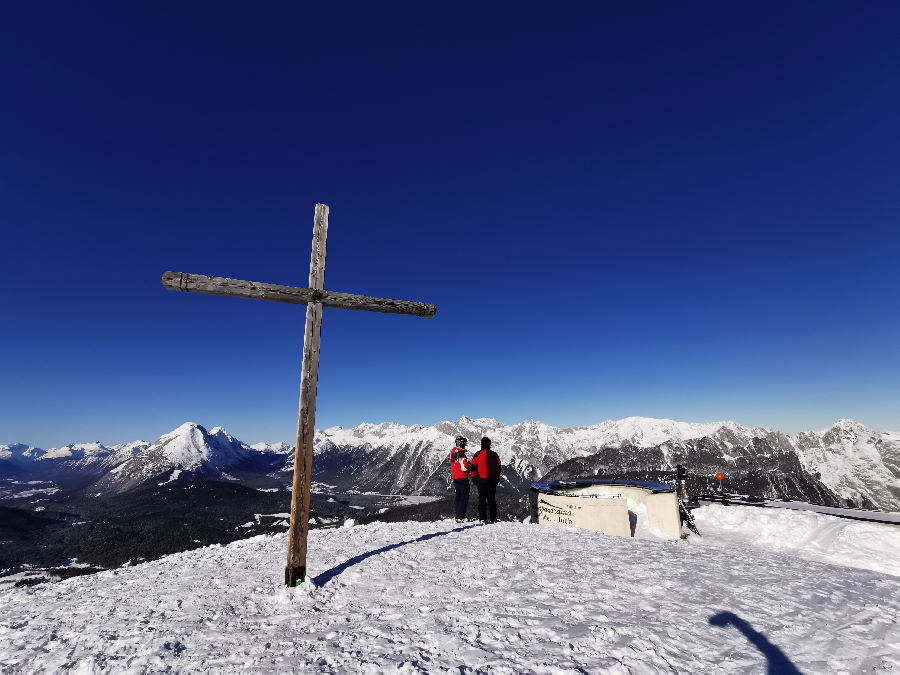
xmin=0 ymin=1 xmax=900 ymax=447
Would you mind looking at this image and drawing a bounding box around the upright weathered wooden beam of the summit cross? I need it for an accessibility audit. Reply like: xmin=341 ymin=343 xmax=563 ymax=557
xmin=284 ymin=204 xmax=328 ymax=588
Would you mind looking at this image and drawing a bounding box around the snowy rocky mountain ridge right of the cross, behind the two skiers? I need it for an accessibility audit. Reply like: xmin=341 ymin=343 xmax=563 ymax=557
xmin=306 ymin=417 xmax=900 ymax=510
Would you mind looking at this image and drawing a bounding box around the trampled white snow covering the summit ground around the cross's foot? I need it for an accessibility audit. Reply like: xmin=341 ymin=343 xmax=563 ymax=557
xmin=0 ymin=506 xmax=900 ymax=673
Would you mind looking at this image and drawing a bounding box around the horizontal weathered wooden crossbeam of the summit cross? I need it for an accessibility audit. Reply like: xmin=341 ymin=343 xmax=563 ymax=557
xmin=162 ymin=272 xmax=437 ymax=319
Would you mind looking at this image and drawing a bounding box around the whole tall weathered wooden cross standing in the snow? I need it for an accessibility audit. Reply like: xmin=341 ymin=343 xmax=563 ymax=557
xmin=162 ymin=204 xmax=435 ymax=587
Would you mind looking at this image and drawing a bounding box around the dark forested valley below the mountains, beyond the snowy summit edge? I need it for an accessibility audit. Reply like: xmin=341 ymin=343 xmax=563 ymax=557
xmin=0 ymin=481 xmax=529 ymax=588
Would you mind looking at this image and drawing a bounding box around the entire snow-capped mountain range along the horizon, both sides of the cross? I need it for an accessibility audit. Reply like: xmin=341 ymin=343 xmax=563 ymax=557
xmin=0 ymin=417 xmax=900 ymax=510
